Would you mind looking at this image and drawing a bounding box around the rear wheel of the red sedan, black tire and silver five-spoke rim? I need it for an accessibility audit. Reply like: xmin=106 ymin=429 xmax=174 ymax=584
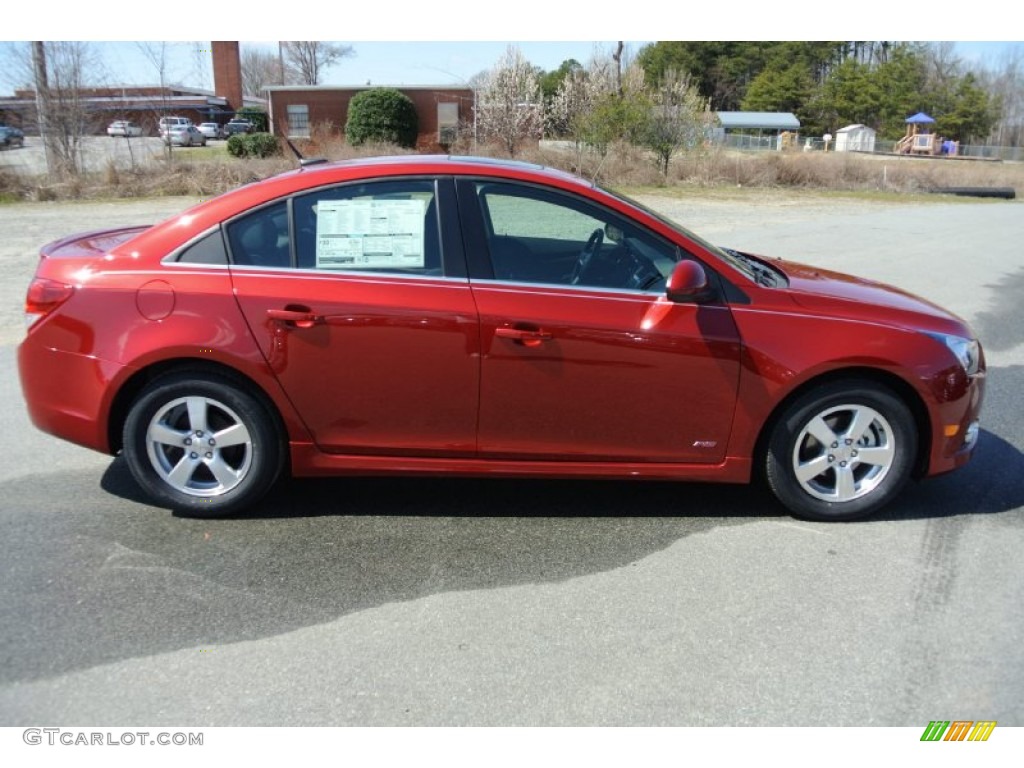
xmin=123 ymin=372 xmax=285 ymax=517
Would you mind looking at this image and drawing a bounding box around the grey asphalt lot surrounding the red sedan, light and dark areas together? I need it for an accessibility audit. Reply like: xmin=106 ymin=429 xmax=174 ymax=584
xmin=0 ymin=196 xmax=1024 ymax=728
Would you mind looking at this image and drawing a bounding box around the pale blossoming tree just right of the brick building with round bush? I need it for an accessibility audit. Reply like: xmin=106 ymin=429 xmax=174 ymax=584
xmin=477 ymin=45 xmax=544 ymax=157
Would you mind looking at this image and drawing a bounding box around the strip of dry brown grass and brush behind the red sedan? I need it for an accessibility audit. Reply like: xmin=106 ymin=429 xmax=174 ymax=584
xmin=0 ymin=130 xmax=1024 ymax=203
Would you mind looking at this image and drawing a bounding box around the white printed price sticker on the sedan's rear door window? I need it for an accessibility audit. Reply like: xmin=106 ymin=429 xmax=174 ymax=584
xmin=316 ymin=200 xmax=427 ymax=269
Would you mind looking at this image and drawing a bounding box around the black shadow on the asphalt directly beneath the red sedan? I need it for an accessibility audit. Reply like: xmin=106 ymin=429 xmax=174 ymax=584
xmin=100 ymin=429 xmax=1024 ymax=523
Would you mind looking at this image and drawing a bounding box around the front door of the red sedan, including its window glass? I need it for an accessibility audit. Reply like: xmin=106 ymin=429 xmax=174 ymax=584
xmin=460 ymin=181 xmax=739 ymax=463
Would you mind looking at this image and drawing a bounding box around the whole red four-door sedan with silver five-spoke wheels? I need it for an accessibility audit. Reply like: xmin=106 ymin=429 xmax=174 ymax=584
xmin=18 ymin=157 xmax=985 ymax=520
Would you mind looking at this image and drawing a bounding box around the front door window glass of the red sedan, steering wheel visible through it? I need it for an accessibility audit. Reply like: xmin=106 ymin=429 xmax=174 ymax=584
xmin=476 ymin=181 xmax=677 ymax=291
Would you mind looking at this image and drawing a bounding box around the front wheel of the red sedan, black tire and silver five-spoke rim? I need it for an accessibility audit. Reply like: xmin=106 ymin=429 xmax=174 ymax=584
xmin=765 ymin=379 xmax=918 ymax=521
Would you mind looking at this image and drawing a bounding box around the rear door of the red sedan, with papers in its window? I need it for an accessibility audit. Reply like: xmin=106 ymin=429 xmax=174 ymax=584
xmin=226 ymin=178 xmax=479 ymax=457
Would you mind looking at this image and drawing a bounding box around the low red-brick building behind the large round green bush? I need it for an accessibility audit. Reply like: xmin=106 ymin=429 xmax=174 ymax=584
xmin=267 ymin=85 xmax=474 ymax=152
